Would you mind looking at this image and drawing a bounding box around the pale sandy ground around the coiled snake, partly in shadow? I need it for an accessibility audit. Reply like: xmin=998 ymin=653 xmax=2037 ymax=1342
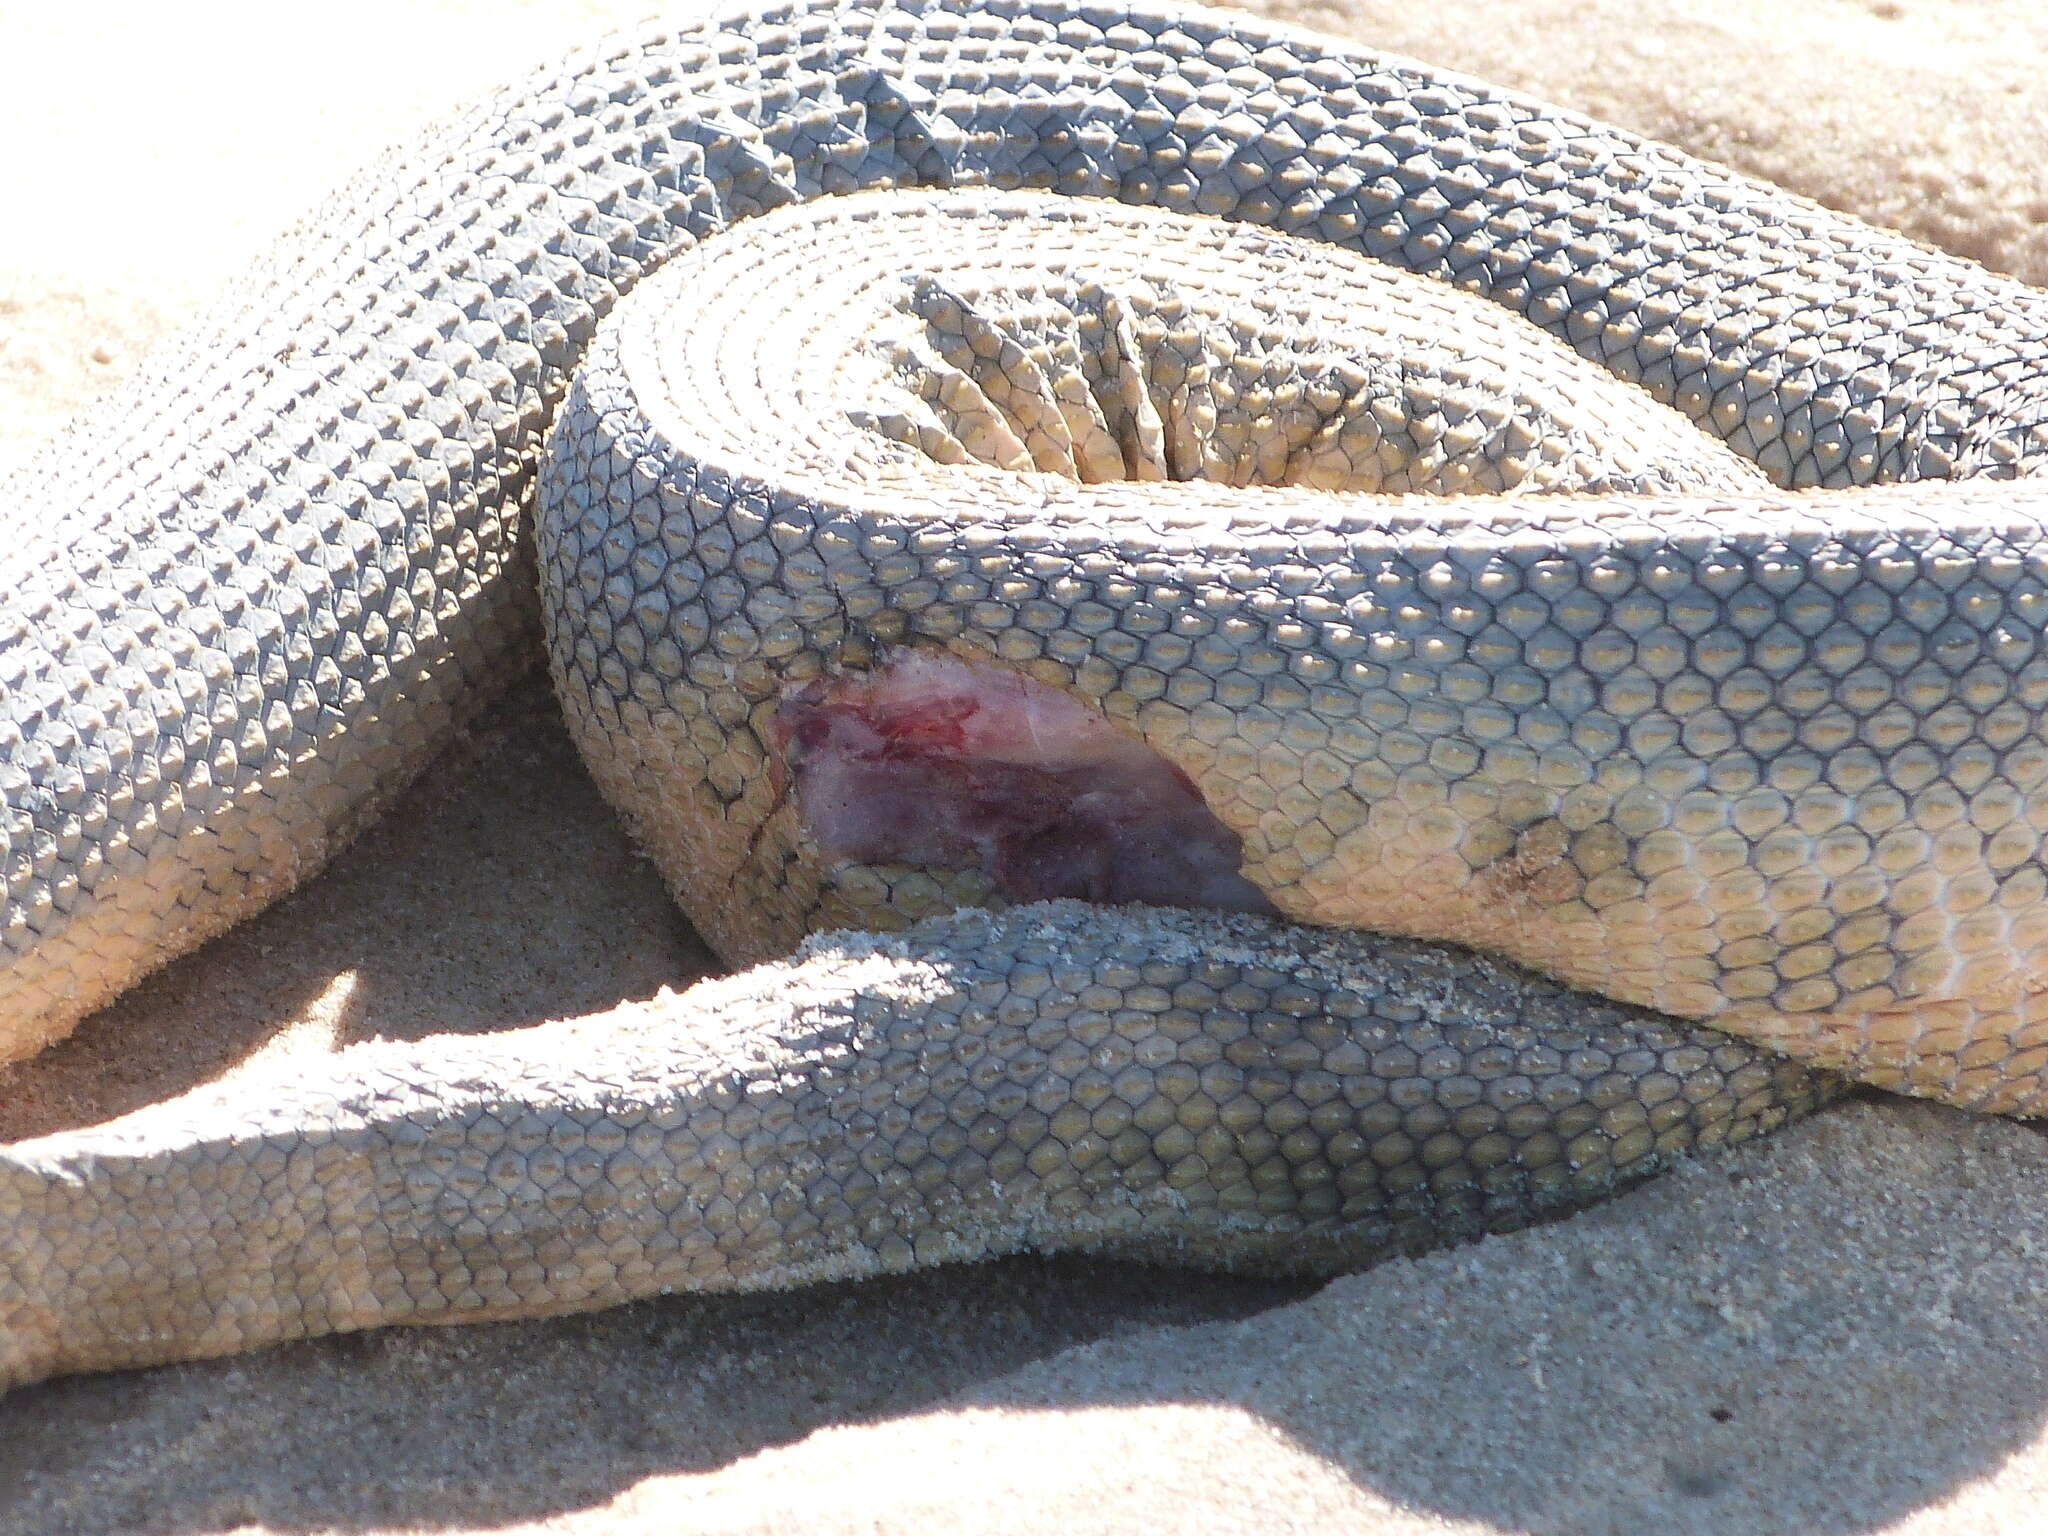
xmin=0 ymin=0 xmax=2048 ymax=1536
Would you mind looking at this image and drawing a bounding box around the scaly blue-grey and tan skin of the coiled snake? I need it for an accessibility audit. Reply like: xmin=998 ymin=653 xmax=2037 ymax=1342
xmin=0 ymin=0 xmax=2048 ymax=1384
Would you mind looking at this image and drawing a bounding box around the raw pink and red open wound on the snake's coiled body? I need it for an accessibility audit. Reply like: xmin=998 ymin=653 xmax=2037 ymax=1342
xmin=774 ymin=651 xmax=1272 ymax=911
